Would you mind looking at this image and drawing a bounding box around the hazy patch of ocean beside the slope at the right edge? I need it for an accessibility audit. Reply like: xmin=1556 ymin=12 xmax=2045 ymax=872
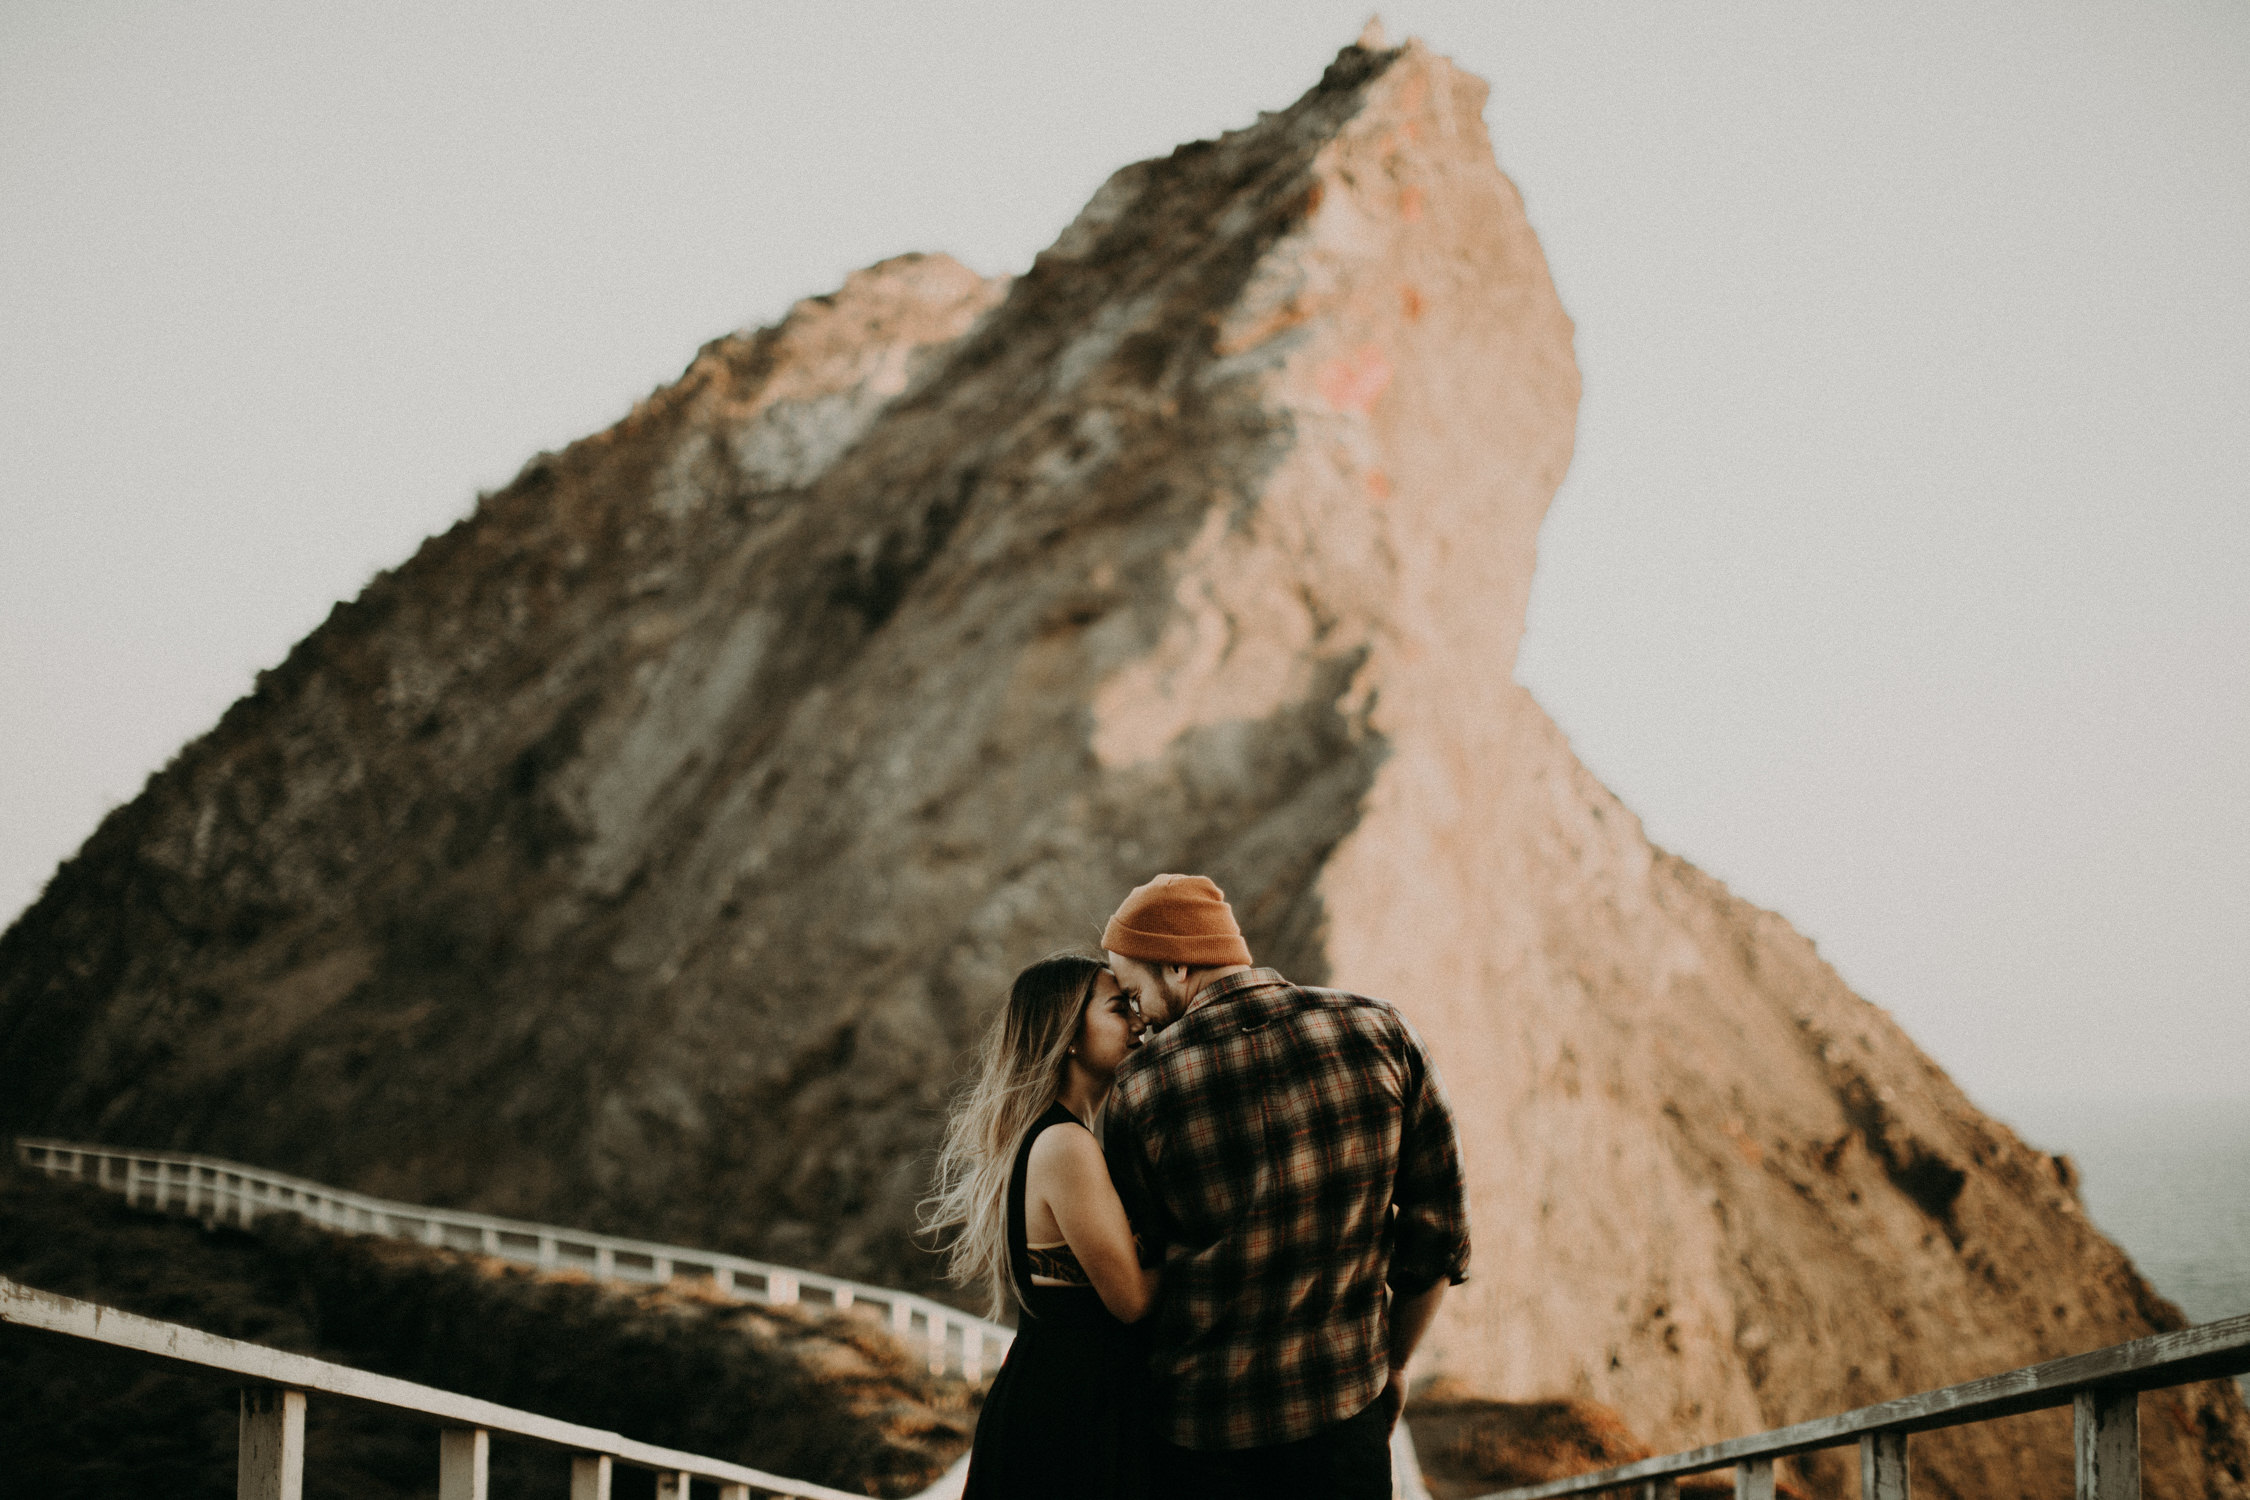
xmin=1989 ymin=1097 xmax=2250 ymax=1390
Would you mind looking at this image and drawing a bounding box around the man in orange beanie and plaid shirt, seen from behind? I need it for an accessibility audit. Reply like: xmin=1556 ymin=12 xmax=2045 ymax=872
xmin=1103 ymin=875 xmax=1469 ymax=1500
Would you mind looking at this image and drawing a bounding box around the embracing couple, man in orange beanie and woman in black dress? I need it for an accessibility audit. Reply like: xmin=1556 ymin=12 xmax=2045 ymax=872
xmin=927 ymin=875 xmax=1469 ymax=1500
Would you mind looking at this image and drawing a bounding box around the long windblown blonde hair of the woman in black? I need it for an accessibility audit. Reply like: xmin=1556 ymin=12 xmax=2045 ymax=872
xmin=920 ymin=954 xmax=1105 ymax=1318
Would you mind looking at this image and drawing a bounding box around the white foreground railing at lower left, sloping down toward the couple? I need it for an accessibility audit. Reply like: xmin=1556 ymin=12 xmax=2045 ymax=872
xmin=0 ymin=1277 xmax=864 ymax=1500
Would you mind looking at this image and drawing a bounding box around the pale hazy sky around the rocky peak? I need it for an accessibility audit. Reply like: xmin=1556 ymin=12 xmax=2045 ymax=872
xmin=0 ymin=0 xmax=2250 ymax=1104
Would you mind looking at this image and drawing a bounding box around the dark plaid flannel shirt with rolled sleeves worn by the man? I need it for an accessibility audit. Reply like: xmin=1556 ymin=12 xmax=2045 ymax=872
xmin=1105 ymin=969 xmax=1469 ymax=1448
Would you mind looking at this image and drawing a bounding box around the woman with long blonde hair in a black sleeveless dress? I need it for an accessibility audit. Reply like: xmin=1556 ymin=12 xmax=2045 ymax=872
xmin=923 ymin=954 xmax=1157 ymax=1500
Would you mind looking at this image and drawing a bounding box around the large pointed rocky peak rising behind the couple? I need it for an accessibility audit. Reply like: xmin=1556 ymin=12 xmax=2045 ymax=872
xmin=0 ymin=35 xmax=2246 ymax=1496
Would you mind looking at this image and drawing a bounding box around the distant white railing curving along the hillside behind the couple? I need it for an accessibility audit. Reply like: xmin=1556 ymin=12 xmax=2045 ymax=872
xmin=16 ymin=1136 xmax=1015 ymax=1383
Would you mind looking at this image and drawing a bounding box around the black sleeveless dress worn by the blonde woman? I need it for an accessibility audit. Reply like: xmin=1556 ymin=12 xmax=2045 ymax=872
xmin=961 ymin=1104 xmax=1150 ymax=1500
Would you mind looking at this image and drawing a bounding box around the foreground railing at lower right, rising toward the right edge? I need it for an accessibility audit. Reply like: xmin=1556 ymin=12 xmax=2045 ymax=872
xmin=1478 ymin=1313 xmax=2250 ymax=1500
